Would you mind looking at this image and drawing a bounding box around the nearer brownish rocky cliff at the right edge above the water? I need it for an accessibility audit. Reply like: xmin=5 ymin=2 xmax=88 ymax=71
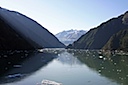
xmin=103 ymin=28 xmax=128 ymax=51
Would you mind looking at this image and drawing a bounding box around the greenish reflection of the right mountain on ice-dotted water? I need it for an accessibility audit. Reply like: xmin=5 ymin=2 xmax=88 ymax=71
xmin=70 ymin=51 xmax=128 ymax=85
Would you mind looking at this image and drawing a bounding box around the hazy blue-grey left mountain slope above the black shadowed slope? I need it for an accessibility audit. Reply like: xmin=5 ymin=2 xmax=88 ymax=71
xmin=0 ymin=7 xmax=65 ymax=48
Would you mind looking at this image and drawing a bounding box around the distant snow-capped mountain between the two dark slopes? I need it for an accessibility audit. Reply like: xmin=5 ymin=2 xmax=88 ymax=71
xmin=55 ymin=30 xmax=86 ymax=45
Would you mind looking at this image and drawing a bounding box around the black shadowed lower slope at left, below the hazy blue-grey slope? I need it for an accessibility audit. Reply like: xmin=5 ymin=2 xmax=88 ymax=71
xmin=0 ymin=19 xmax=34 ymax=50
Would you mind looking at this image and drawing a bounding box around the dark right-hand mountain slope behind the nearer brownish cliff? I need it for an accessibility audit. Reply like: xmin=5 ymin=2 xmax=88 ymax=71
xmin=68 ymin=12 xmax=128 ymax=49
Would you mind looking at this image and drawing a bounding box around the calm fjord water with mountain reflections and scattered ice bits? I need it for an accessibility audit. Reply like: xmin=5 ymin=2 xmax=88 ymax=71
xmin=0 ymin=49 xmax=128 ymax=85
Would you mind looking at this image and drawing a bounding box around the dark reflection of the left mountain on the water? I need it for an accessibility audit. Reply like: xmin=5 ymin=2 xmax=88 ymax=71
xmin=0 ymin=51 xmax=56 ymax=84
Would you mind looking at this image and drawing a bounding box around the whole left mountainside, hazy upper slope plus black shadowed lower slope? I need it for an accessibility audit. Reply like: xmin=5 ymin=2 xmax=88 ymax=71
xmin=0 ymin=8 xmax=65 ymax=49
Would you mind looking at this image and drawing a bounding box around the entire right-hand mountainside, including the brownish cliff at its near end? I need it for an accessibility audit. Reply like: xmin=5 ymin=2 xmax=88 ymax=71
xmin=67 ymin=11 xmax=128 ymax=50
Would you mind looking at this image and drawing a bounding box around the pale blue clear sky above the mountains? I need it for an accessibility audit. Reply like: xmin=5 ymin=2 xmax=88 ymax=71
xmin=0 ymin=0 xmax=128 ymax=34
